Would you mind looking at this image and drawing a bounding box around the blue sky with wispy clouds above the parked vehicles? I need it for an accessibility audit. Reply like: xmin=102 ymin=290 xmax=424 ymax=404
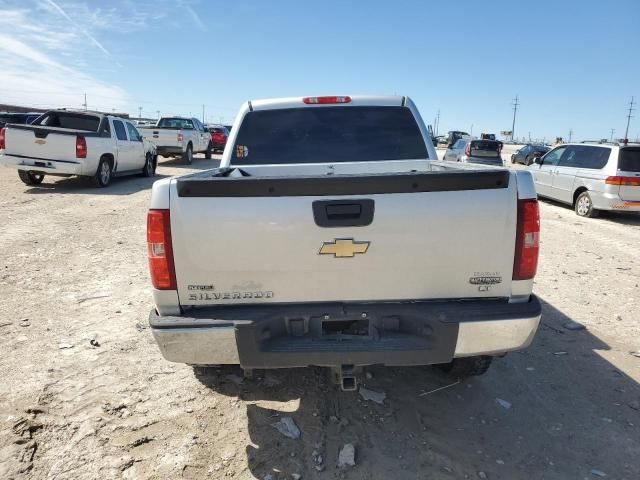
xmin=0 ymin=0 xmax=640 ymax=139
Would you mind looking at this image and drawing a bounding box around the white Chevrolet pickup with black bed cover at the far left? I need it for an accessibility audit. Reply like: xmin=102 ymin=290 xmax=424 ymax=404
xmin=0 ymin=110 xmax=156 ymax=187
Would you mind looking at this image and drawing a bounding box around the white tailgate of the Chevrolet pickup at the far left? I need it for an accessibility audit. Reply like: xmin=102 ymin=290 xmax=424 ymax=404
xmin=5 ymin=126 xmax=78 ymax=160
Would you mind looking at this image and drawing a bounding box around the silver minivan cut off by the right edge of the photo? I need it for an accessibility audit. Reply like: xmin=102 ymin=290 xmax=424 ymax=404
xmin=529 ymin=143 xmax=640 ymax=217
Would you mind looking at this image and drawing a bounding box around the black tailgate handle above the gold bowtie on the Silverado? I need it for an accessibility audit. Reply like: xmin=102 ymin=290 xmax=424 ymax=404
xmin=313 ymin=198 xmax=375 ymax=227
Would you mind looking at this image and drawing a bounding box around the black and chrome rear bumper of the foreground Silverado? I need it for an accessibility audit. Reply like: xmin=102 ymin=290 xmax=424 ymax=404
xmin=149 ymin=295 xmax=541 ymax=368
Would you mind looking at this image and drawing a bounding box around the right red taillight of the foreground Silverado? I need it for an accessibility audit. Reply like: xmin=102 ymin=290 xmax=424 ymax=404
xmin=513 ymin=199 xmax=540 ymax=280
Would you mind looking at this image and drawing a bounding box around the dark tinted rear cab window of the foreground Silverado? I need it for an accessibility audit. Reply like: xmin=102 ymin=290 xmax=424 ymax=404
xmin=231 ymin=106 xmax=429 ymax=165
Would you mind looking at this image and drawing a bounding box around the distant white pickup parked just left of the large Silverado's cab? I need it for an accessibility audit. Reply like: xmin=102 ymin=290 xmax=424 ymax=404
xmin=139 ymin=117 xmax=213 ymax=164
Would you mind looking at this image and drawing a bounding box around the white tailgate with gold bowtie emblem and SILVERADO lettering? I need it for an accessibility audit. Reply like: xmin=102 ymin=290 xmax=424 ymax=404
xmin=170 ymin=170 xmax=517 ymax=305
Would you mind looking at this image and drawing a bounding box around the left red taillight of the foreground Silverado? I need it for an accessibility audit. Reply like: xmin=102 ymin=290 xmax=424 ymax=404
xmin=147 ymin=210 xmax=176 ymax=290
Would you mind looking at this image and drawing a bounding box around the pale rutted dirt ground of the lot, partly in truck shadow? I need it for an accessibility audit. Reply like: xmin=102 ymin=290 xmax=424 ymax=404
xmin=0 ymin=153 xmax=640 ymax=480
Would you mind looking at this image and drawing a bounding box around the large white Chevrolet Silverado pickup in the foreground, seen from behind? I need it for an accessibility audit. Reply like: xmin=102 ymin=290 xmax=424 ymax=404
xmin=147 ymin=96 xmax=541 ymax=390
